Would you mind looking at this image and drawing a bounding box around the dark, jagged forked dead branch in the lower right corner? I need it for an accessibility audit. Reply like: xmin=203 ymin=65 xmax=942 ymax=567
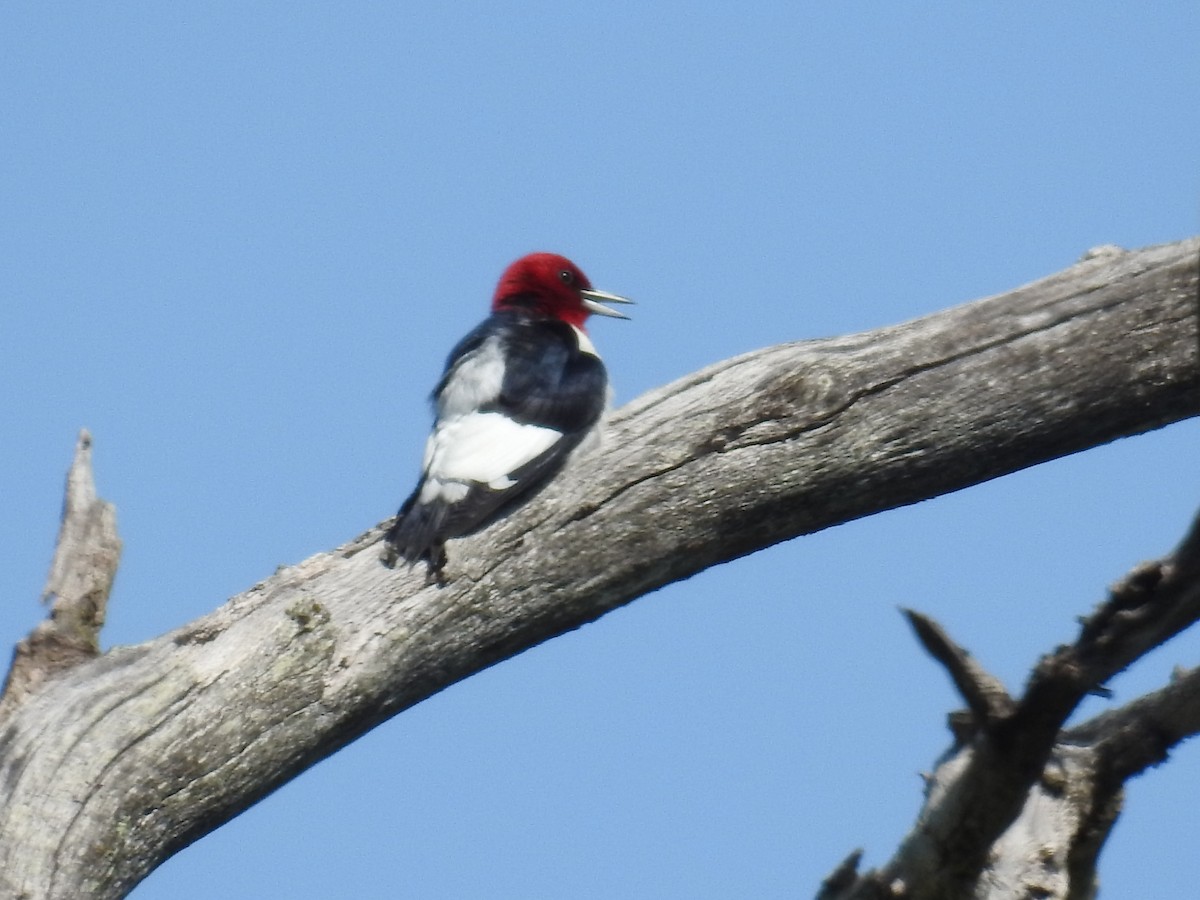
xmin=818 ymin=508 xmax=1200 ymax=900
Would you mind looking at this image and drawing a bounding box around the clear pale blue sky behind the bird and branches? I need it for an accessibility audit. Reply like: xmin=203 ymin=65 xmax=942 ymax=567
xmin=0 ymin=2 xmax=1200 ymax=900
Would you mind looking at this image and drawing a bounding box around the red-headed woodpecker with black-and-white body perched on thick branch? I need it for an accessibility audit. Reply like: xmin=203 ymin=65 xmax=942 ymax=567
xmin=383 ymin=253 xmax=632 ymax=571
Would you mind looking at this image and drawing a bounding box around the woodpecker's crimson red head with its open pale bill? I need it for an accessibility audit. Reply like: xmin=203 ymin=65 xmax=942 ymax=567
xmin=492 ymin=253 xmax=631 ymax=328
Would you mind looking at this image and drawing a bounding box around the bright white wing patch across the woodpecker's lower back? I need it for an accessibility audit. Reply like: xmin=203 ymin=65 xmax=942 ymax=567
xmin=420 ymin=413 xmax=563 ymax=503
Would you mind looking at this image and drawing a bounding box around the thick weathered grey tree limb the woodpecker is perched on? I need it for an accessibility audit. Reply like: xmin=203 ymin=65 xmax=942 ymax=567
xmin=0 ymin=240 xmax=1200 ymax=898
